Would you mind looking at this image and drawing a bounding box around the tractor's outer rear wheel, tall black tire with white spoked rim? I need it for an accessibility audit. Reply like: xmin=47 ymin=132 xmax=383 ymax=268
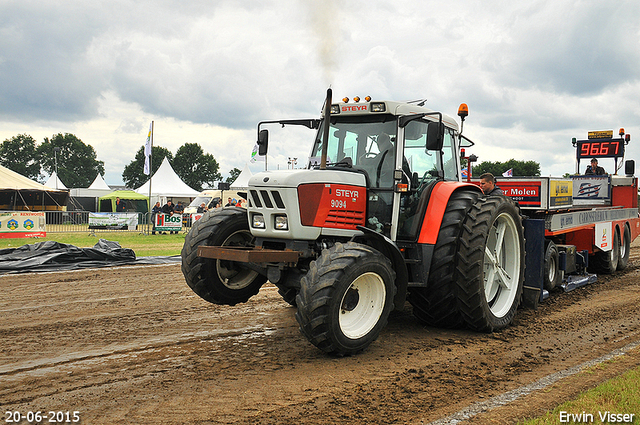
xmin=456 ymin=196 xmax=525 ymax=332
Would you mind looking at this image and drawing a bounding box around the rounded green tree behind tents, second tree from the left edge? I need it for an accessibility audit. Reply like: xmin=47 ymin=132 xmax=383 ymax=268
xmin=36 ymin=133 xmax=104 ymax=187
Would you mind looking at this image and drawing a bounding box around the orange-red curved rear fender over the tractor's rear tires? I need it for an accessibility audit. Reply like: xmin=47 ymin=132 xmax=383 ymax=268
xmin=418 ymin=182 xmax=482 ymax=245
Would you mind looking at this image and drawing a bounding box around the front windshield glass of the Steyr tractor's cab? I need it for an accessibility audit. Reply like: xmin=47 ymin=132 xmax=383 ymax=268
xmin=309 ymin=115 xmax=396 ymax=187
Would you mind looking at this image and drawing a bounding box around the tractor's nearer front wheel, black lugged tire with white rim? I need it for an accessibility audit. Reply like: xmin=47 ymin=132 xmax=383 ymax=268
xmin=296 ymin=242 xmax=396 ymax=356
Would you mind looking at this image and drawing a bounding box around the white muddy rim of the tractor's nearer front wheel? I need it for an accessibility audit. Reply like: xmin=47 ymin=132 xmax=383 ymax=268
xmin=338 ymin=272 xmax=387 ymax=339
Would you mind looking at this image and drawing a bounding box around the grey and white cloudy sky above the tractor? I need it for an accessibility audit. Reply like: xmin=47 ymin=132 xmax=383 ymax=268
xmin=0 ymin=0 xmax=640 ymax=184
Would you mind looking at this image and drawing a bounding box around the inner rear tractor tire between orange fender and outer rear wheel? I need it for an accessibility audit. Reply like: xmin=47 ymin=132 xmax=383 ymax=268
xmin=408 ymin=191 xmax=480 ymax=328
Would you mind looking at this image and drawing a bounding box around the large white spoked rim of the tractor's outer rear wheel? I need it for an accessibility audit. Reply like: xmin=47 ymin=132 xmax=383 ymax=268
xmin=484 ymin=213 xmax=521 ymax=318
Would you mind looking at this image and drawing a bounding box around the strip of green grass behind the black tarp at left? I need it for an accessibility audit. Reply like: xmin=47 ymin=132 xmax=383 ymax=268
xmin=0 ymin=232 xmax=185 ymax=257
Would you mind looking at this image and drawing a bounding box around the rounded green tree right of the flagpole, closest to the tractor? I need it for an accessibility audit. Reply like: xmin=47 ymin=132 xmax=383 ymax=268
xmin=172 ymin=143 xmax=222 ymax=190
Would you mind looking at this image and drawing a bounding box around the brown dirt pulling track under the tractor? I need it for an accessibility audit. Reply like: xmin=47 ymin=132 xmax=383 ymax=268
xmin=0 ymin=242 xmax=640 ymax=424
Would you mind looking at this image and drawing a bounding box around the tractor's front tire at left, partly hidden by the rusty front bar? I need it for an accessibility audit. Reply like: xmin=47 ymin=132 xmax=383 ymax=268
xmin=181 ymin=208 xmax=267 ymax=305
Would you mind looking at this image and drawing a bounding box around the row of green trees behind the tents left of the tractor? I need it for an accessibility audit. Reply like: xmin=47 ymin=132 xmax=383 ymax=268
xmin=0 ymin=133 xmax=240 ymax=190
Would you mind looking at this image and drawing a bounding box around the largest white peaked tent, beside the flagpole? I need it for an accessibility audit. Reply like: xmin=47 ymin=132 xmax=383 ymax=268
xmin=136 ymin=157 xmax=199 ymax=206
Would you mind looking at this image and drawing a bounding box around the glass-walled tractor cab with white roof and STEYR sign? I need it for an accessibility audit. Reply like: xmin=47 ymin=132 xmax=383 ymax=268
xmin=308 ymin=99 xmax=460 ymax=240
